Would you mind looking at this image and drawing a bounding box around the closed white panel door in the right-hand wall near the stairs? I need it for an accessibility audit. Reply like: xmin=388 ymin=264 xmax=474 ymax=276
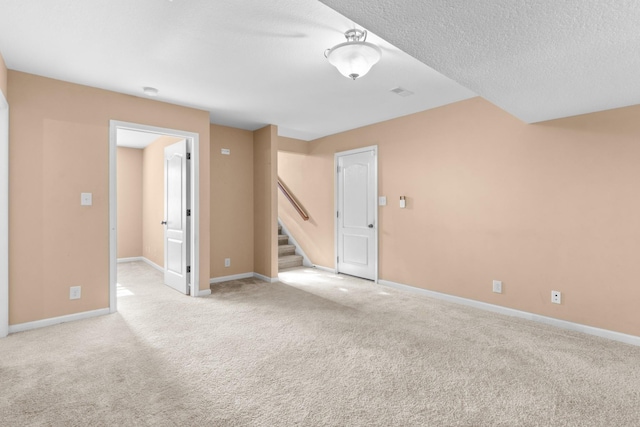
xmin=336 ymin=148 xmax=378 ymax=280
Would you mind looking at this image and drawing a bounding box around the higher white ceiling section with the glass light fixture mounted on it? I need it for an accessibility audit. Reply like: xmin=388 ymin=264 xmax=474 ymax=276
xmin=0 ymin=0 xmax=475 ymax=140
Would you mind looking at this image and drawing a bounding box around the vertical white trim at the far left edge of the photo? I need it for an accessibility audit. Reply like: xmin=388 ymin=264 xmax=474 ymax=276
xmin=0 ymin=91 xmax=9 ymax=338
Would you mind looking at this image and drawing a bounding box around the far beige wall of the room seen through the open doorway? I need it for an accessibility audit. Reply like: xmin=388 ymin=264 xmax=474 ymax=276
xmin=117 ymin=147 xmax=142 ymax=258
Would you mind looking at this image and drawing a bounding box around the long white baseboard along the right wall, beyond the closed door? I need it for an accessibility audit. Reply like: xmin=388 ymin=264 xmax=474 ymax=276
xmin=378 ymin=279 xmax=640 ymax=346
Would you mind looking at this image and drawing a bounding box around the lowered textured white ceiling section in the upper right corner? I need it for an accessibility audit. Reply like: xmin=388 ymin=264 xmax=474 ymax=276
xmin=320 ymin=0 xmax=640 ymax=123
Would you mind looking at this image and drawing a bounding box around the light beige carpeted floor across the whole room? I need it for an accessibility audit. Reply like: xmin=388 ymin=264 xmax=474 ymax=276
xmin=0 ymin=263 xmax=640 ymax=427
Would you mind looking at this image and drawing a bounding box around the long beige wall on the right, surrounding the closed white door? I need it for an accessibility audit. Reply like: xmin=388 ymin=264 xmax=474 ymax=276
xmin=278 ymin=98 xmax=640 ymax=335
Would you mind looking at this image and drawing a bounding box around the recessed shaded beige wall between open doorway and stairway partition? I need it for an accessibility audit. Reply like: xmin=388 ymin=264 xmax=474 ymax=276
xmin=210 ymin=125 xmax=254 ymax=278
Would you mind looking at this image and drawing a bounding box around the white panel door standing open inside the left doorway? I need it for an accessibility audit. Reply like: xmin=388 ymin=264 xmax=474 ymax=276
xmin=163 ymin=140 xmax=191 ymax=295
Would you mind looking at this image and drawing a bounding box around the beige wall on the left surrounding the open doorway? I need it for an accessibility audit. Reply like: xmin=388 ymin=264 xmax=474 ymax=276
xmin=8 ymin=70 xmax=210 ymax=324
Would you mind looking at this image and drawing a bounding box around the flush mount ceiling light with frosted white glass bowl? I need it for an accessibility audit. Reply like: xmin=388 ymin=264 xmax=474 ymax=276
xmin=324 ymin=29 xmax=381 ymax=80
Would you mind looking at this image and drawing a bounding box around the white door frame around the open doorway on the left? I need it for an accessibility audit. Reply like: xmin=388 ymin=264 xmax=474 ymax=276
xmin=109 ymin=120 xmax=200 ymax=313
